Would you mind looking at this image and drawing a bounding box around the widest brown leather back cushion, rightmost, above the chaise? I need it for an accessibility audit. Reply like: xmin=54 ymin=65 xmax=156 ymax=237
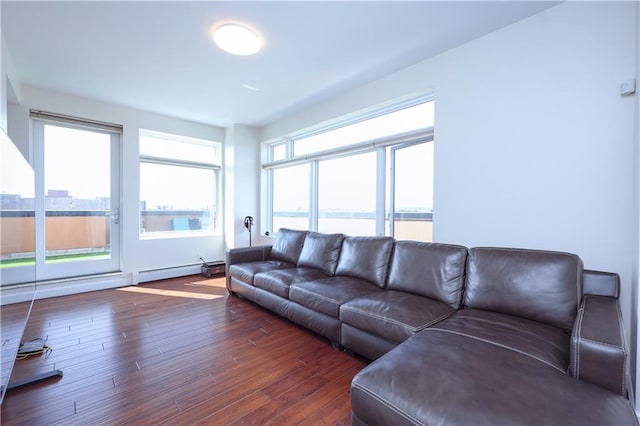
xmin=463 ymin=247 xmax=583 ymax=331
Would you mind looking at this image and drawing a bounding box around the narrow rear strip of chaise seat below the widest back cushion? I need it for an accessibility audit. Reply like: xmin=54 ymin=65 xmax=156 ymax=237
xmin=434 ymin=309 xmax=571 ymax=373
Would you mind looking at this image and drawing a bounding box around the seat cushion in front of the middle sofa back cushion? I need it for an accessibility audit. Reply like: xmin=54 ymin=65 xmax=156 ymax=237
xmin=289 ymin=276 xmax=382 ymax=318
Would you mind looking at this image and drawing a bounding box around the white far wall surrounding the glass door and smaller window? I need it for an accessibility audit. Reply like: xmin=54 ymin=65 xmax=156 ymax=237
xmin=9 ymin=86 xmax=225 ymax=294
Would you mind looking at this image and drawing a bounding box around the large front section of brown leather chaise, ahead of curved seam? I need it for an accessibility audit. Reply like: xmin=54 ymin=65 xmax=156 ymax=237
xmin=351 ymin=328 xmax=636 ymax=426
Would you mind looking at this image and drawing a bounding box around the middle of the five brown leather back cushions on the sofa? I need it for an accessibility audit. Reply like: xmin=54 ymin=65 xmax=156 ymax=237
xmin=336 ymin=237 xmax=393 ymax=288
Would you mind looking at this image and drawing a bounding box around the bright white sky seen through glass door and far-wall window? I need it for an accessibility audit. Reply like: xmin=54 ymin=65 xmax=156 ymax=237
xmin=0 ymin=125 xmax=216 ymax=213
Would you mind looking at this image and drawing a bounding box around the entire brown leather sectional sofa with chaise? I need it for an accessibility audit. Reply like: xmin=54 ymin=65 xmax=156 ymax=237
xmin=226 ymin=229 xmax=637 ymax=425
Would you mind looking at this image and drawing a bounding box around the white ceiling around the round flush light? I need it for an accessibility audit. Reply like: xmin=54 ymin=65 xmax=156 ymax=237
xmin=1 ymin=0 xmax=557 ymax=127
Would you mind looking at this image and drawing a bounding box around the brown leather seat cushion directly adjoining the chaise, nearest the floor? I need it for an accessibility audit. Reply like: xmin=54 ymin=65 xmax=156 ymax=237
xmin=340 ymin=290 xmax=455 ymax=343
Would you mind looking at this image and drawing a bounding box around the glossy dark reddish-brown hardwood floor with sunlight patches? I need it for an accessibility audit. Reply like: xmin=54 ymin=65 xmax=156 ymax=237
xmin=0 ymin=276 xmax=366 ymax=425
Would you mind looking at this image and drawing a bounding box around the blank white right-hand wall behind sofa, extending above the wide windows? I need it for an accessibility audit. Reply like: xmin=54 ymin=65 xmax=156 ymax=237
xmin=261 ymin=2 xmax=639 ymax=388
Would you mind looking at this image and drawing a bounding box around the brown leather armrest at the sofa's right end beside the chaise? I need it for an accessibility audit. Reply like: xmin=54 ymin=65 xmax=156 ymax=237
xmin=569 ymin=294 xmax=627 ymax=397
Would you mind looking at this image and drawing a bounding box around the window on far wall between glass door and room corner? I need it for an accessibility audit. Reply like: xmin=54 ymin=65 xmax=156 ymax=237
xmin=140 ymin=130 xmax=220 ymax=238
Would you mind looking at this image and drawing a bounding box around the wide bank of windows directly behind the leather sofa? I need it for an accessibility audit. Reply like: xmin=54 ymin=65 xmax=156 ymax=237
xmin=263 ymin=98 xmax=434 ymax=241
